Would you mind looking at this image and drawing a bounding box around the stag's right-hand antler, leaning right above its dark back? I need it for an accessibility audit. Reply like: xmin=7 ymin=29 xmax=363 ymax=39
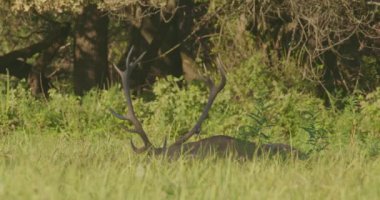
xmin=172 ymin=57 xmax=227 ymax=146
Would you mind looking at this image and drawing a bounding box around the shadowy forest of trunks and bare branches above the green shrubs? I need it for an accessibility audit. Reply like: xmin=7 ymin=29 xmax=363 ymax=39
xmin=0 ymin=0 xmax=380 ymax=105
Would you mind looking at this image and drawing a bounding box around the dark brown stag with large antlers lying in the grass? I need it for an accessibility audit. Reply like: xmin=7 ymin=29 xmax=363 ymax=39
xmin=110 ymin=47 xmax=300 ymax=159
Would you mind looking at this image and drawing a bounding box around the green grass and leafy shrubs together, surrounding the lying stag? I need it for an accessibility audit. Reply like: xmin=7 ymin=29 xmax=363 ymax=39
xmin=0 ymin=56 xmax=380 ymax=199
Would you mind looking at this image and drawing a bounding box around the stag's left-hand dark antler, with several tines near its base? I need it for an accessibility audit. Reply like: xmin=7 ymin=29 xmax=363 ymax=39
xmin=110 ymin=46 xmax=153 ymax=153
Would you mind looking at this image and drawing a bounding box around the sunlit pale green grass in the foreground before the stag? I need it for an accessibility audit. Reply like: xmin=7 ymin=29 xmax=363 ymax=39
xmin=0 ymin=133 xmax=380 ymax=199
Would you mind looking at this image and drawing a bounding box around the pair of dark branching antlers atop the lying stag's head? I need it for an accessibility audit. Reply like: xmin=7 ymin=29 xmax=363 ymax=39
xmin=110 ymin=46 xmax=226 ymax=154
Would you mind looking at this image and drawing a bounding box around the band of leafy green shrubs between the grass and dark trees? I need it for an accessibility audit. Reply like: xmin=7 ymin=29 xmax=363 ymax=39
xmin=0 ymin=52 xmax=380 ymax=152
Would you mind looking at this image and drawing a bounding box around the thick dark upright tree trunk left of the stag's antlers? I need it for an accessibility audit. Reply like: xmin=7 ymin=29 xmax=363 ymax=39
xmin=74 ymin=4 xmax=109 ymax=95
